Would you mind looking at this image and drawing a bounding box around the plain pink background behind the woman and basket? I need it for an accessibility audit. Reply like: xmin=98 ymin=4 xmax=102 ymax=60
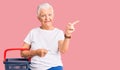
xmin=0 ymin=0 xmax=120 ymax=70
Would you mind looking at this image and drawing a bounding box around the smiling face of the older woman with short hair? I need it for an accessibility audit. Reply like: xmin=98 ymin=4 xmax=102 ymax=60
xmin=38 ymin=8 xmax=54 ymax=26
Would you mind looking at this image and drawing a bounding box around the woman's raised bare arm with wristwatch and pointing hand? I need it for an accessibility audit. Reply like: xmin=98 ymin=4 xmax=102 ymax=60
xmin=58 ymin=21 xmax=79 ymax=53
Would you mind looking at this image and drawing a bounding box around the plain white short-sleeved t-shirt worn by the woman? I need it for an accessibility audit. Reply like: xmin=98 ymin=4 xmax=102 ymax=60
xmin=24 ymin=27 xmax=64 ymax=70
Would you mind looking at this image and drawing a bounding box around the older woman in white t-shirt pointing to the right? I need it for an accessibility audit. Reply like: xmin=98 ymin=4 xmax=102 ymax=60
xmin=21 ymin=3 xmax=78 ymax=70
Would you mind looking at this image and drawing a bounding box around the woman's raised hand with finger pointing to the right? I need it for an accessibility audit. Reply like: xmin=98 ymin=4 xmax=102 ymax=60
xmin=65 ymin=20 xmax=79 ymax=36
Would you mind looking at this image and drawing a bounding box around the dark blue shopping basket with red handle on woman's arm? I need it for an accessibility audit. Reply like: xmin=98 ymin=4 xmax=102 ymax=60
xmin=3 ymin=48 xmax=30 ymax=70
